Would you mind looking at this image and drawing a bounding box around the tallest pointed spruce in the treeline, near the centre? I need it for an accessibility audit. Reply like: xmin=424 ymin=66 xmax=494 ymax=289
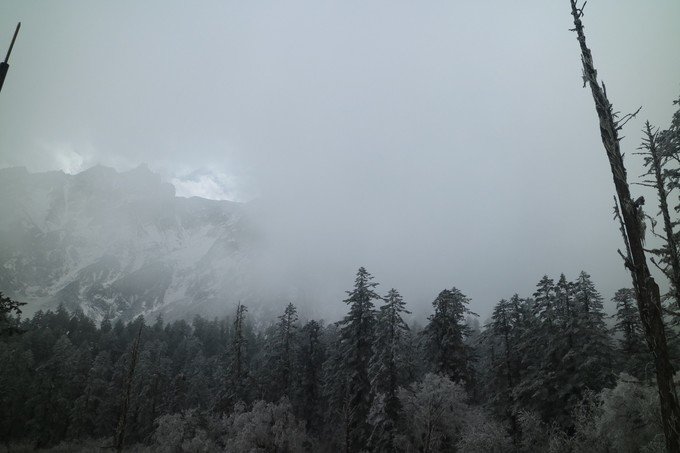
xmin=338 ymin=267 xmax=380 ymax=451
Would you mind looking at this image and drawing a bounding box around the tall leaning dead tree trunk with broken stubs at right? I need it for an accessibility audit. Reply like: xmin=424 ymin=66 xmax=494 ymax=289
xmin=570 ymin=0 xmax=680 ymax=453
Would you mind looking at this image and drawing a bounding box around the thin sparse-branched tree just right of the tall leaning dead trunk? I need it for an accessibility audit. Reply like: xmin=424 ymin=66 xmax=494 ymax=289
xmin=637 ymin=121 xmax=680 ymax=308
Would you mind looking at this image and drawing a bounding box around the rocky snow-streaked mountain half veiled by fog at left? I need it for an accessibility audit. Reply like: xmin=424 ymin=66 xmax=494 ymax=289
xmin=0 ymin=166 xmax=261 ymax=319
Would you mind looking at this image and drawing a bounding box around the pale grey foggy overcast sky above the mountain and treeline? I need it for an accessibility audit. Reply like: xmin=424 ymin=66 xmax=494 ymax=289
xmin=0 ymin=0 xmax=680 ymax=315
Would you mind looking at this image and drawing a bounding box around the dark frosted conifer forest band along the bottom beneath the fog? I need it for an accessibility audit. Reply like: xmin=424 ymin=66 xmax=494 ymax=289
xmin=0 ymin=268 xmax=677 ymax=452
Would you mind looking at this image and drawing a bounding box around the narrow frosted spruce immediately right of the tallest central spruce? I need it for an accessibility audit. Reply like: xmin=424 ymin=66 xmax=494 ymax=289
xmin=369 ymin=288 xmax=410 ymax=451
